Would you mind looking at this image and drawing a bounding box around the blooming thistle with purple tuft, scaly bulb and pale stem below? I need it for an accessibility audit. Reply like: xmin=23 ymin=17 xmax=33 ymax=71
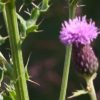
xmin=60 ymin=13 xmax=99 ymax=100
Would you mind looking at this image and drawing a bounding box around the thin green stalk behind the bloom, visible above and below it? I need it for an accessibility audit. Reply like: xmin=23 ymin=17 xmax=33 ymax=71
xmin=59 ymin=0 xmax=76 ymax=100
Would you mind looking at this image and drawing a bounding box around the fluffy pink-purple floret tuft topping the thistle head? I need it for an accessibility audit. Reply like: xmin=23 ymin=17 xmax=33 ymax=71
xmin=59 ymin=16 xmax=99 ymax=45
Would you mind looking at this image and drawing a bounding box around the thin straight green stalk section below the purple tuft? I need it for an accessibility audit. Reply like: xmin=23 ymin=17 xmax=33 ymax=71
xmin=59 ymin=45 xmax=72 ymax=100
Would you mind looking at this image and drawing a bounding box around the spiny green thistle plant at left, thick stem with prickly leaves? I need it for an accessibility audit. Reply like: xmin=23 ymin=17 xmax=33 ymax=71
xmin=0 ymin=0 xmax=49 ymax=100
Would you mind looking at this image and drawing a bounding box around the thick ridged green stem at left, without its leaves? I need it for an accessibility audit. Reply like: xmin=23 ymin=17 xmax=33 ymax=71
xmin=2 ymin=0 xmax=29 ymax=100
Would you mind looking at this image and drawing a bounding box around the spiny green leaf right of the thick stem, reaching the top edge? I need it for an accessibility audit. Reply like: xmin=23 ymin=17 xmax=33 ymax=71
xmin=17 ymin=0 xmax=49 ymax=39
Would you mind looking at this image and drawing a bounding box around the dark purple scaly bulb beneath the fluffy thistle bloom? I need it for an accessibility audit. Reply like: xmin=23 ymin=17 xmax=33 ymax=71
xmin=73 ymin=44 xmax=99 ymax=76
